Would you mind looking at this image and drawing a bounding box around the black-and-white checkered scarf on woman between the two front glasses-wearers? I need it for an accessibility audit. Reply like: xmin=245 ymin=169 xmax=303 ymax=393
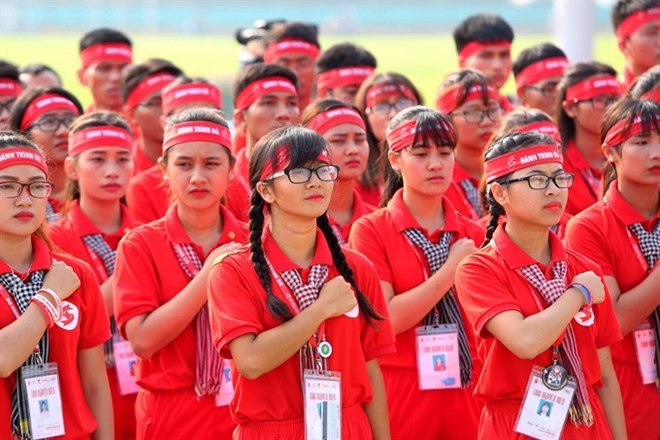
xmin=403 ymin=228 xmax=472 ymax=388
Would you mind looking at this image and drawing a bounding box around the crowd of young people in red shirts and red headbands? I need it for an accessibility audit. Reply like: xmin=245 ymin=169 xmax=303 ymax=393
xmin=0 ymin=0 xmax=660 ymax=440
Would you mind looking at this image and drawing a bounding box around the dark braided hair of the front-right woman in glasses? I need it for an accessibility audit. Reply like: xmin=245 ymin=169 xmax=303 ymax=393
xmin=481 ymin=132 xmax=555 ymax=247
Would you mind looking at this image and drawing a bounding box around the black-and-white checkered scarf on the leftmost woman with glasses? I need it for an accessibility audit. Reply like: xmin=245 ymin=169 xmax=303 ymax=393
xmin=0 ymin=270 xmax=49 ymax=439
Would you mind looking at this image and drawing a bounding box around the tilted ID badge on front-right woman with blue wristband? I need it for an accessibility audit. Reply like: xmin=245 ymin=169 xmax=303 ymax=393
xmin=515 ymin=366 xmax=576 ymax=440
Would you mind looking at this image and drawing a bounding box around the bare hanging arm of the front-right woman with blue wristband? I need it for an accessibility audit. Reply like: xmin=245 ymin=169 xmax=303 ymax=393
xmin=596 ymin=347 xmax=628 ymax=440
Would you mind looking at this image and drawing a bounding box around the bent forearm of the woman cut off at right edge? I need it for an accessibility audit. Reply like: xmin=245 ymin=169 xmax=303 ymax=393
xmin=605 ymin=265 xmax=660 ymax=335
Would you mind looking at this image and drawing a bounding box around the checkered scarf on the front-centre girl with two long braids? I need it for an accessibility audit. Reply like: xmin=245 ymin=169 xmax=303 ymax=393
xmin=280 ymin=264 xmax=328 ymax=370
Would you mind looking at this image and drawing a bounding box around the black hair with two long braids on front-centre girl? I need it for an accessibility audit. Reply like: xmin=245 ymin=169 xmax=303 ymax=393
xmin=249 ymin=127 xmax=383 ymax=324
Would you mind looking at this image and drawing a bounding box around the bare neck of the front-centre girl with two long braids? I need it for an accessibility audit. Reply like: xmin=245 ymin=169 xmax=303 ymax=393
xmin=270 ymin=212 xmax=316 ymax=268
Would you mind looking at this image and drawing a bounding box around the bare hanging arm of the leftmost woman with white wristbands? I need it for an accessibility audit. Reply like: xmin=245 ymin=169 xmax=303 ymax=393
xmin=78 ymin=345 xmax=115 ymax=440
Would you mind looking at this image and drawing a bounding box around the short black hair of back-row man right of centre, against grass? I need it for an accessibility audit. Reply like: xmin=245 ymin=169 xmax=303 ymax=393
xmin=453 ymin=14 xmax=514 ymax=52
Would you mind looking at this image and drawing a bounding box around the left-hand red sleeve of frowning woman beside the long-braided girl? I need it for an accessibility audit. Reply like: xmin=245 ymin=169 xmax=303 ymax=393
xmin=114 ymin=230 xmax=160 ymax=338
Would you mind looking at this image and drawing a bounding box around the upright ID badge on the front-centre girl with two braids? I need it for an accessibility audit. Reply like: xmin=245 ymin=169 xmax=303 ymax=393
xmin=303 ymin=370 xmax=341 ymax=440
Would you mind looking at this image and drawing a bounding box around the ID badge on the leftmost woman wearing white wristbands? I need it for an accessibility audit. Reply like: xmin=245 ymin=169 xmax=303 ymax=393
xmin=21 ymin=362 xmax=65 ymax=440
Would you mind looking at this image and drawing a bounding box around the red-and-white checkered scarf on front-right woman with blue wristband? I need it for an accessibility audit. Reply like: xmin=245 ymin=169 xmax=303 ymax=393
xmin=520 ymin=261 xmax=594 ymax=426
